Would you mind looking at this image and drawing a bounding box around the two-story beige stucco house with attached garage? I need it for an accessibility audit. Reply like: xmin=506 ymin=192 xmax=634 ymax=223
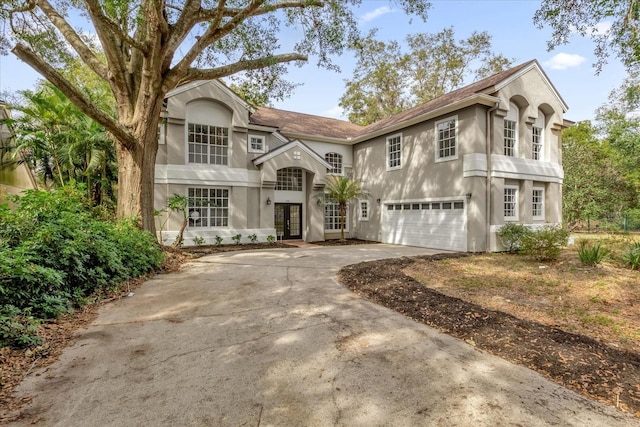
xmin=155 ymin=61 xmax=567 ymax=252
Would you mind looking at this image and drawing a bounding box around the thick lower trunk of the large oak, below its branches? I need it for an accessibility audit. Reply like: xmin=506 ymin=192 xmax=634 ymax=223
xmin=116 ymin=120 xmax=158 ymax=235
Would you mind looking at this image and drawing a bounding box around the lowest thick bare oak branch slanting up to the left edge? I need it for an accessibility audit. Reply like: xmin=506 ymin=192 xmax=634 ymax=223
xmin=11 ymin=43 xmax=136 ymax=148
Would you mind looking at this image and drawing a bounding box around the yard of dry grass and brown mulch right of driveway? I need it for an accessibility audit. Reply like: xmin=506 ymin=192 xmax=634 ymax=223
xmin=340 ymin=241 xmax=640 ymax=416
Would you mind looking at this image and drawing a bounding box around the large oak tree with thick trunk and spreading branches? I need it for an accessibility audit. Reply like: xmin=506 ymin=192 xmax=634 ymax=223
xmin=0 ymin=0 xmax=430 ymax=231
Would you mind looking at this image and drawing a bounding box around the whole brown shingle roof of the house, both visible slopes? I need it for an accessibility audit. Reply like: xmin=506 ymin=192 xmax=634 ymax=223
xmin=250 ymin=60 xmax=536 ymax=139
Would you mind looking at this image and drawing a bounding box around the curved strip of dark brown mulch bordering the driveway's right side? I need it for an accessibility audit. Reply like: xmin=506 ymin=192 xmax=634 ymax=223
xmin=339 ymin=254 xmax=640 ymax=417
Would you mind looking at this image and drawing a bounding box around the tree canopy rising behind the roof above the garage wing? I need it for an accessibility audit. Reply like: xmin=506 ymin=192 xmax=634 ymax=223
xmin=340 ymin=28 xmax=513 ymax=125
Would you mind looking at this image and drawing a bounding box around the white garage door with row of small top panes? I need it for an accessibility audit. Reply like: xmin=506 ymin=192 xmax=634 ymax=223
xmin=382 ymin=200 xmax=467 ymax=252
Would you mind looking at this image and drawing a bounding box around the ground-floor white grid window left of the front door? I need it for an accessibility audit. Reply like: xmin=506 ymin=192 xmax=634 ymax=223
xmin=187 ymin=188 xmax=229 ymax=227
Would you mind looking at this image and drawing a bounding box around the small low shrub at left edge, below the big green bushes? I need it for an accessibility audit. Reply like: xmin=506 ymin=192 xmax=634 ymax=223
xmin=0 ymin=305 xmax=42 ymax=348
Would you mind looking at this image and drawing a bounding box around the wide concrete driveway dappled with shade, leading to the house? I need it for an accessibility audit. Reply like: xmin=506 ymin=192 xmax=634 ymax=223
xmin=7 ymin=245 xmax=640 ymax=427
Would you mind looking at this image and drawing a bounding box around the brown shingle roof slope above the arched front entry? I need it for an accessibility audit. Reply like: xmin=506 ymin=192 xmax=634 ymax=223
xmin=249 ymin=107 xmax=363 ymax=139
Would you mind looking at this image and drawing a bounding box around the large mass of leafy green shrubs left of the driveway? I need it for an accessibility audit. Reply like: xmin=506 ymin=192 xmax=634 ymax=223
xmin=0 ymin=187 xmax=164 ymax=330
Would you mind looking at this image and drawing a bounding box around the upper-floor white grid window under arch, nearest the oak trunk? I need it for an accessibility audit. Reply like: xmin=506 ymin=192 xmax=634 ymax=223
xmin=187 ymin=123 xmax=229 ymax=165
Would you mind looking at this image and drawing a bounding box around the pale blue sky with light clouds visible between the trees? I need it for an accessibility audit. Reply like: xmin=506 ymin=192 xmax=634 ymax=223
xmin=0 ymin=0 xmax=626 ymax=121
